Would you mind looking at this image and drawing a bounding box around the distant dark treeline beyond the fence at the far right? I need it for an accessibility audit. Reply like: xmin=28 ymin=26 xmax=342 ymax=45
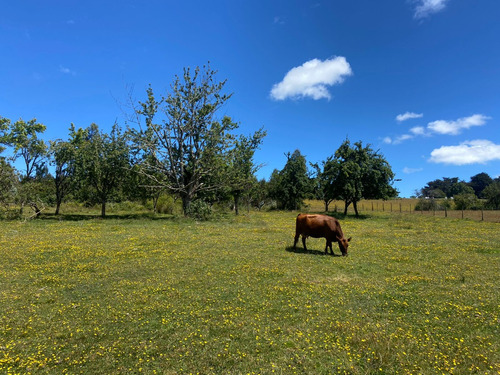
xmin=417 ymin=172 xmax=500 ymax=210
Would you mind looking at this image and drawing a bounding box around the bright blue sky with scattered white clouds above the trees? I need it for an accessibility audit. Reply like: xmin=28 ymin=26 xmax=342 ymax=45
xmin=0 ymin=0 xmax=500 ymax=196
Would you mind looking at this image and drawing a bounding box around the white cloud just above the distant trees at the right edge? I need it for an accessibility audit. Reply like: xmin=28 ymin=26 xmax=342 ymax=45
xmin=429 ymin=139 xmax=500 ymax=165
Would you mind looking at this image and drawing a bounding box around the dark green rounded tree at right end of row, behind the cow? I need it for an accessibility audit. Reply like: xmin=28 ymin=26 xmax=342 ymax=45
xmin=328 ymin=139 xmax=397 ymax=216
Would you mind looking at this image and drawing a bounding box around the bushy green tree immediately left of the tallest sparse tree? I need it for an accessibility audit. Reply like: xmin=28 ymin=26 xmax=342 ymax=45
xmin=70 ymin=124 xmax=130 ymax=217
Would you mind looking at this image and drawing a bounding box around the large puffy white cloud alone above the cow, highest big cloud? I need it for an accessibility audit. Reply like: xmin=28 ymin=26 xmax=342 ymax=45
xmin=271 ymin=56 xmax=352 ymax=100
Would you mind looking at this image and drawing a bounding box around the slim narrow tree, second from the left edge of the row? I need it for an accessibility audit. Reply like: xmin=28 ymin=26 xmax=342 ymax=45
xmin=49 ymin=137 xmax=76 ymax=215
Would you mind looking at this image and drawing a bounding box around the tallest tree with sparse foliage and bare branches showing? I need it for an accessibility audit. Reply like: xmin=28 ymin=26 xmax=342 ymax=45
xmin=134 ymin=66 xmax=244 ymax=215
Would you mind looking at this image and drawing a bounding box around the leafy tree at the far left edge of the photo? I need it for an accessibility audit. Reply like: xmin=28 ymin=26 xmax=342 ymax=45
xmin=2 ymin=119 xmax=47 ymax=180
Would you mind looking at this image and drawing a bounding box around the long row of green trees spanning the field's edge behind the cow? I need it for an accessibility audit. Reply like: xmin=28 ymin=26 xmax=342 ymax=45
xmin=0 ymin=66 xmax=397 ymax=217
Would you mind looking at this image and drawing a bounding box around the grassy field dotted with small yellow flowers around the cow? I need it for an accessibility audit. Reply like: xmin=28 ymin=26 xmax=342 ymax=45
xmin=0 ymin=212 xmax=500 ymax=374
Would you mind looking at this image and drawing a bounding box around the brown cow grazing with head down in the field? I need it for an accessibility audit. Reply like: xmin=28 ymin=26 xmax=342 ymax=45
xmin=293 ymin=214 xmax=351 ymax=256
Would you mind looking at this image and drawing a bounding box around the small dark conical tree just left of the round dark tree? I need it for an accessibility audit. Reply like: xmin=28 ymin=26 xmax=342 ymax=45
xmin=269 ymin=150 xmax=312 ymax=210
